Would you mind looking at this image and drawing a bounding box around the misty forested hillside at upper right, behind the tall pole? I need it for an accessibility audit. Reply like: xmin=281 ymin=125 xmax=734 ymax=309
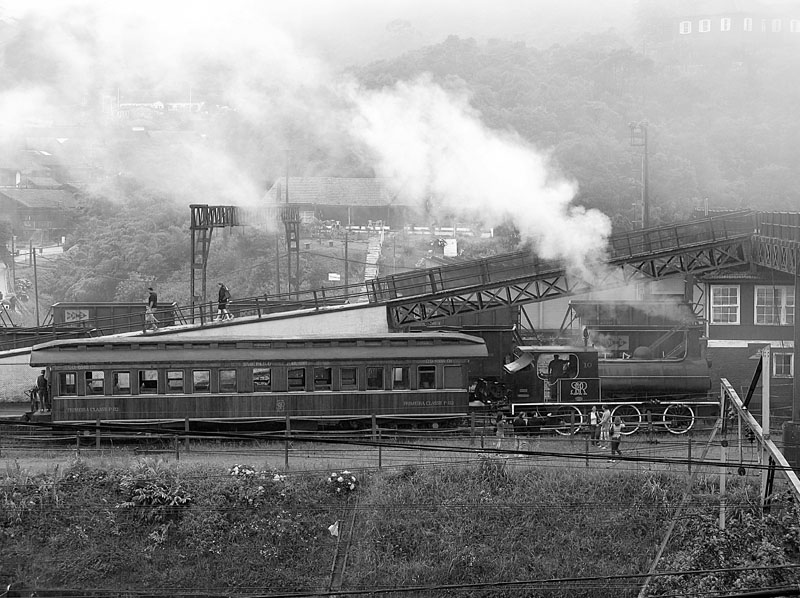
xmin=358 ymin=32 xmax=800 ymax=228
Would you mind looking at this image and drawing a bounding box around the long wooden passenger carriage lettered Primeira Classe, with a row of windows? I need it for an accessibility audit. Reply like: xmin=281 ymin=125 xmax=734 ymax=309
xmin=30 ymin=332 xmax=486 ymax=427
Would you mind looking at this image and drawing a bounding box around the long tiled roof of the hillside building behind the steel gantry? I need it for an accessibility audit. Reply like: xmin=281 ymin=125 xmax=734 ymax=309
xmin=265 ymin=177 xmax=410 ymax=206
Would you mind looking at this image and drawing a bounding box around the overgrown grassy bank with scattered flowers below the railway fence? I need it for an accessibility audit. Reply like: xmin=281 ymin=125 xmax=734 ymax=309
xmin=0 ymin=444 xmax=800 ymax=597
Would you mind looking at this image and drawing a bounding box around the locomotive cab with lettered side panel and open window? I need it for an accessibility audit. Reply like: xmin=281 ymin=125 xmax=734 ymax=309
xmin=503 ymin=346 xmax=600 ymax=403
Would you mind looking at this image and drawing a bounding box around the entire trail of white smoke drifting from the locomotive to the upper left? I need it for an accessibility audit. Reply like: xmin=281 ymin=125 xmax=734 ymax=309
xmin=0 ymin=0 xmax=611 ymax=274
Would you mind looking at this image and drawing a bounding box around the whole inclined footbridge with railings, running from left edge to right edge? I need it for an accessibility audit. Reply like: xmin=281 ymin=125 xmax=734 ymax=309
xmin=0 ymin=211 xmax=800 ymax=351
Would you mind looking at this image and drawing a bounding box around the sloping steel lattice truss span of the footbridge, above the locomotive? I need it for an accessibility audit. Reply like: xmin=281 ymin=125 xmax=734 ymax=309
xmin=376 ymin=212 xmax=754 ymax=329
